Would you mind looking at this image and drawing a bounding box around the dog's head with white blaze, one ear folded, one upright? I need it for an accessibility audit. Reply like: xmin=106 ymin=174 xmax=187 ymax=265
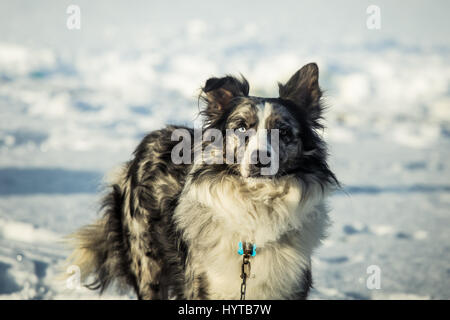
xmin=202 ymin=63 xmax=334 ymax=184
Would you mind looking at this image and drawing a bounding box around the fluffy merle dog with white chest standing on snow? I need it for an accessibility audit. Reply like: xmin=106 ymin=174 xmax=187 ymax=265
xmin=70 ymin=63 xmax=339 ymax=299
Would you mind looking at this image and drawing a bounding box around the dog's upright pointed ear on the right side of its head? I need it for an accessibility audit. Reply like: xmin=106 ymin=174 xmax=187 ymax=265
xmin=278 ymin=63 xmax=322 ymax=110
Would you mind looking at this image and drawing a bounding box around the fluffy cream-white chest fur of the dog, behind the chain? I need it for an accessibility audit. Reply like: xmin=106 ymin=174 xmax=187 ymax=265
xmin=174 ymin=176 xmax=328 ymax=299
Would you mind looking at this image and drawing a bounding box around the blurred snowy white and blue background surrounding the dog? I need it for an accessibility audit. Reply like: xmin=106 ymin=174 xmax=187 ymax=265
xmin=0 ymin=0 xmax=450 ymax=299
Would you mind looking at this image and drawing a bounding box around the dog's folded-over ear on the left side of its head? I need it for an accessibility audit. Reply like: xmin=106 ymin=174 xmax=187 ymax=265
xmin=202 ymin=76 xmax=249 ymax=115
